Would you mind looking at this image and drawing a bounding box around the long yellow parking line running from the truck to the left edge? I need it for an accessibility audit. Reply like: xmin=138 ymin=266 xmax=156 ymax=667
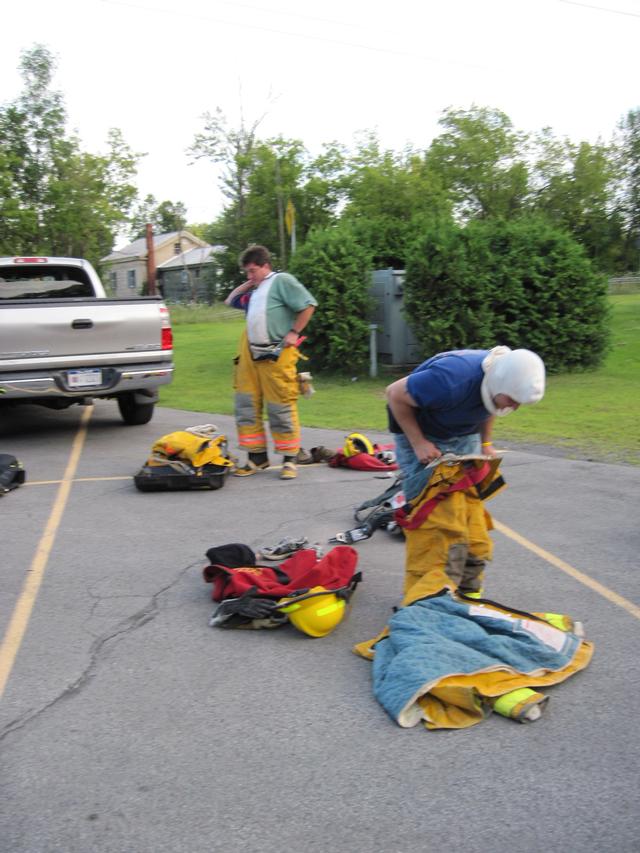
xmin=0 ymin=406 xmax=93 ymax=697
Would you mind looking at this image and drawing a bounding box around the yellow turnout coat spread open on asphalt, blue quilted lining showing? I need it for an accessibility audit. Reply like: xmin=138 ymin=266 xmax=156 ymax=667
xmin=354 ymin=587 xmax=594 ymax=729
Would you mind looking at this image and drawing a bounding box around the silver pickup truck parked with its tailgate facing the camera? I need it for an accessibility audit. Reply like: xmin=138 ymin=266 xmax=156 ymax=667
xmin=0 ymin=257 xmax=173 ymax=424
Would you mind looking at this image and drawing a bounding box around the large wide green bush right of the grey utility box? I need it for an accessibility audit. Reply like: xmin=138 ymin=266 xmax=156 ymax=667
xmin=405 ymin=218 xmax=608 ymax=372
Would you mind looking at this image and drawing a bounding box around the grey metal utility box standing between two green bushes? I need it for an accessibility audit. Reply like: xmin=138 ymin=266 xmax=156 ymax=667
xmin=370 ymin=269 xmax=423 ymax=364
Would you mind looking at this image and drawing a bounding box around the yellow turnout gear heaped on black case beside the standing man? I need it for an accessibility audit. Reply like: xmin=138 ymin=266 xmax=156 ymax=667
xmin=133 ymin=424 xmax=234 ymax=492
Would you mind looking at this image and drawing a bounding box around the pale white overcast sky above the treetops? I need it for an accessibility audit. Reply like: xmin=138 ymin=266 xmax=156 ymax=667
xmin=0 ymin=0 xmax=640 ymax=233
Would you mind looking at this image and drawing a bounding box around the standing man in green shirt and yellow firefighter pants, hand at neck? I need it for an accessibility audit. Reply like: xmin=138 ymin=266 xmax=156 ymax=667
xmin=225 ymin=246 xmax=318 ymax=480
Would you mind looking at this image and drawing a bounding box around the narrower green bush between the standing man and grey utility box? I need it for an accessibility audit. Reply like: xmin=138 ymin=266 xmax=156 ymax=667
xmin=289 ymin=225 xmax=372 ymax=373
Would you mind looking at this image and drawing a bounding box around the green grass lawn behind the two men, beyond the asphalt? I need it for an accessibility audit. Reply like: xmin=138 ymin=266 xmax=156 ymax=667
xmin=160 ymin=294 xmax=640 ymax=464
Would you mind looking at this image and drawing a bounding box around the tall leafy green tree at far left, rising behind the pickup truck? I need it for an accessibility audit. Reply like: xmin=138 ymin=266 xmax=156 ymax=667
xmin=0 ymin=45 xmax=140 ymax=264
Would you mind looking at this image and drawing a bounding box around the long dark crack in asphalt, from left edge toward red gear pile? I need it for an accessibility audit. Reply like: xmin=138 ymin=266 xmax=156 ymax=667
xmin=0 ymin=562 xmax=200 ymax=742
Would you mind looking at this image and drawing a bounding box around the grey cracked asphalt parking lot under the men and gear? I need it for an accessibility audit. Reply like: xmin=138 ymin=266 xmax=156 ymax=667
xmin=0 ymin=402 xmax=640 ymax=853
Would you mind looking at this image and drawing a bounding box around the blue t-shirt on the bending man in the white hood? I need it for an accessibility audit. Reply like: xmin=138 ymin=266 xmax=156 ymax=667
xmin=389 ymin=350 xmax=490 ymax=438
